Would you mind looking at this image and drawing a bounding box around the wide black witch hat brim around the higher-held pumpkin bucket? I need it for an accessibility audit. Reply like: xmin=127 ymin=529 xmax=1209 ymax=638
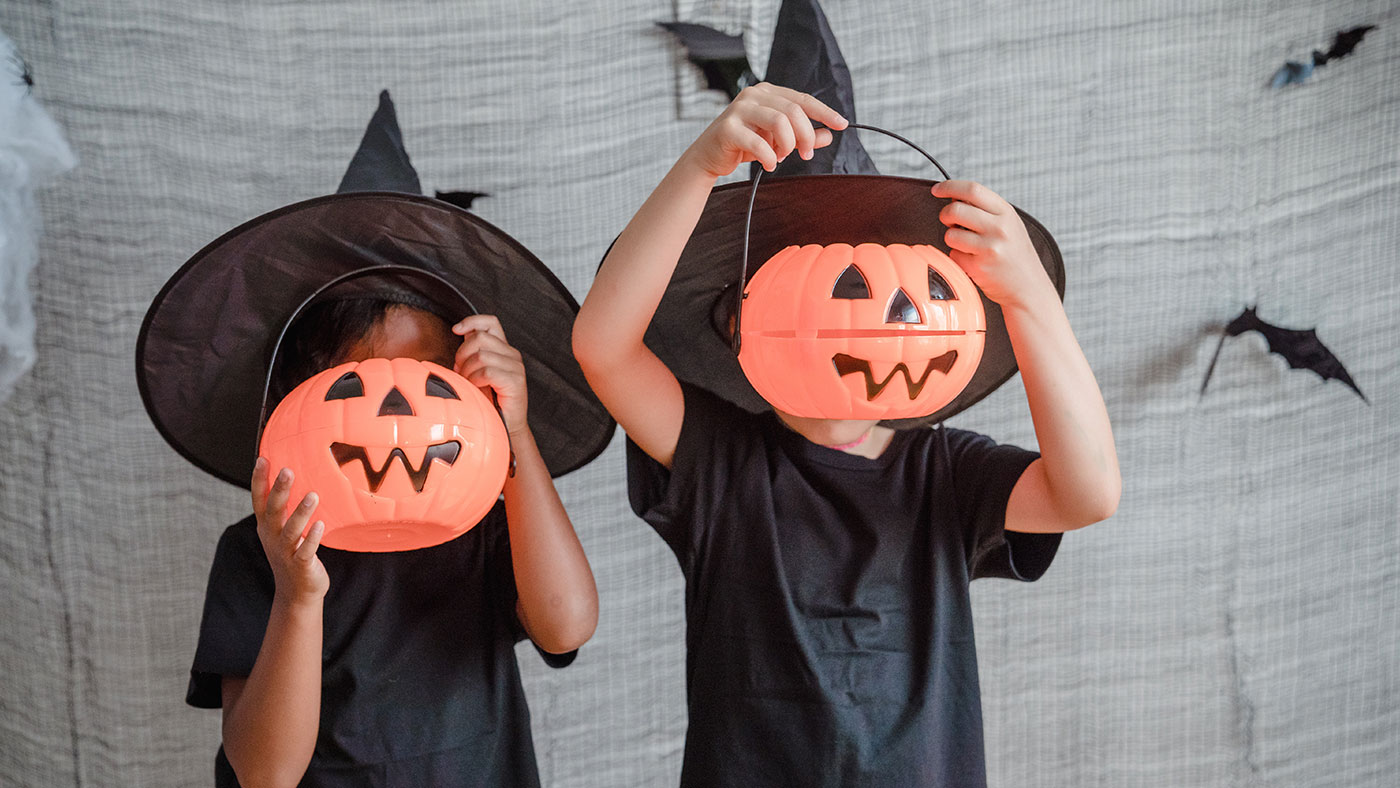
xmin=645 ymin=175 xmax=1064 ymax=428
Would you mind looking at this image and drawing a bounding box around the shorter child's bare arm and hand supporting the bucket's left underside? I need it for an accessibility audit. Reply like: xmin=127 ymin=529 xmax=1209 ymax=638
xmin=223 ymin=458 xmax=330 ymax=788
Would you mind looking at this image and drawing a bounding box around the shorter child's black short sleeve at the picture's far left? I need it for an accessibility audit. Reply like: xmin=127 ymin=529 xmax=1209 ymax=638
xmin=185 ymin=516 xmax=276 ymax=708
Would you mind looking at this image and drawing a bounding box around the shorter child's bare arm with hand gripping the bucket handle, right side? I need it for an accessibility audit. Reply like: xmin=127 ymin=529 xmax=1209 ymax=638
xmin=452 ymin=315 xmax=598 ymax=654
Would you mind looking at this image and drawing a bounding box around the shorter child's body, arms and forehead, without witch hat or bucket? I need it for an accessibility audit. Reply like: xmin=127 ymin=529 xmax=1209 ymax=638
xmin=214 ymin=301 xmax=598 ymax=787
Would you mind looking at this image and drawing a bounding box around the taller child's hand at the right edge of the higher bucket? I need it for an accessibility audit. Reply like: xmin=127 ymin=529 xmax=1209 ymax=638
xmin=932 ymin=181 xmax=1051 ymax=307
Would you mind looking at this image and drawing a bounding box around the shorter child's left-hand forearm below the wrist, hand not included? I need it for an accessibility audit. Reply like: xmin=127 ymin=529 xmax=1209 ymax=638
xmin=224 ymin=598 xmax=322 ymax=788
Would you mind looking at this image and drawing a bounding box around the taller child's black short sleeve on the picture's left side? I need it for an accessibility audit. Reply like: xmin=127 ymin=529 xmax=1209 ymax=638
xmin=627 ymin=381 xmax=746 ymax=563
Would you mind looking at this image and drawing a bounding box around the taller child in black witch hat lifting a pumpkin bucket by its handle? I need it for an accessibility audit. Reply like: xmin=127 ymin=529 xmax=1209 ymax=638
xmin=574 ymin=0 xmax=1120 ymax=788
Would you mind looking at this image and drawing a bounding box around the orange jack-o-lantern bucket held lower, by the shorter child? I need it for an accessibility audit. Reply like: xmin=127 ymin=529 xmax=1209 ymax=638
xmin=260 ymin=358 xmax=511 ymax=551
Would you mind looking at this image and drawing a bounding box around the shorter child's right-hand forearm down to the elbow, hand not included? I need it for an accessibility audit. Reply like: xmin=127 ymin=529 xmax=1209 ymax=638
xmin=505 ymin=428 xmax=598 ymax=654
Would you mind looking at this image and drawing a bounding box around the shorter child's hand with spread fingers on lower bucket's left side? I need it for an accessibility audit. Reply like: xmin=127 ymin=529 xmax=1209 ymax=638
xmin=252 ymin=458 xmax=330 ymax=603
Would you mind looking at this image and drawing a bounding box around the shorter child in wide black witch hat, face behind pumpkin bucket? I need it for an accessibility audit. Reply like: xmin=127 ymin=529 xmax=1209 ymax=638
xmin=137 ymin=92 xmax=612 ymax=787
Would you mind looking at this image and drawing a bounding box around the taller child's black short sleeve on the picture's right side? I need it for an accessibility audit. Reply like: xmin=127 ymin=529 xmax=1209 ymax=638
xmin=946 ymin=430 xmax=1060 ymax=581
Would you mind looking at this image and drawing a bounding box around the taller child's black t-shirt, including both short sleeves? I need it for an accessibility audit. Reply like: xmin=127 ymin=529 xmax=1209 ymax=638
xmin=627 ymin=385 xmax=1060 ymax=788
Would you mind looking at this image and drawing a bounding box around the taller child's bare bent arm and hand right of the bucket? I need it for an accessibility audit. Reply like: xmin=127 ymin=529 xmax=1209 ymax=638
xmin=932 ymin=181 xmax=1123 ymax=533
